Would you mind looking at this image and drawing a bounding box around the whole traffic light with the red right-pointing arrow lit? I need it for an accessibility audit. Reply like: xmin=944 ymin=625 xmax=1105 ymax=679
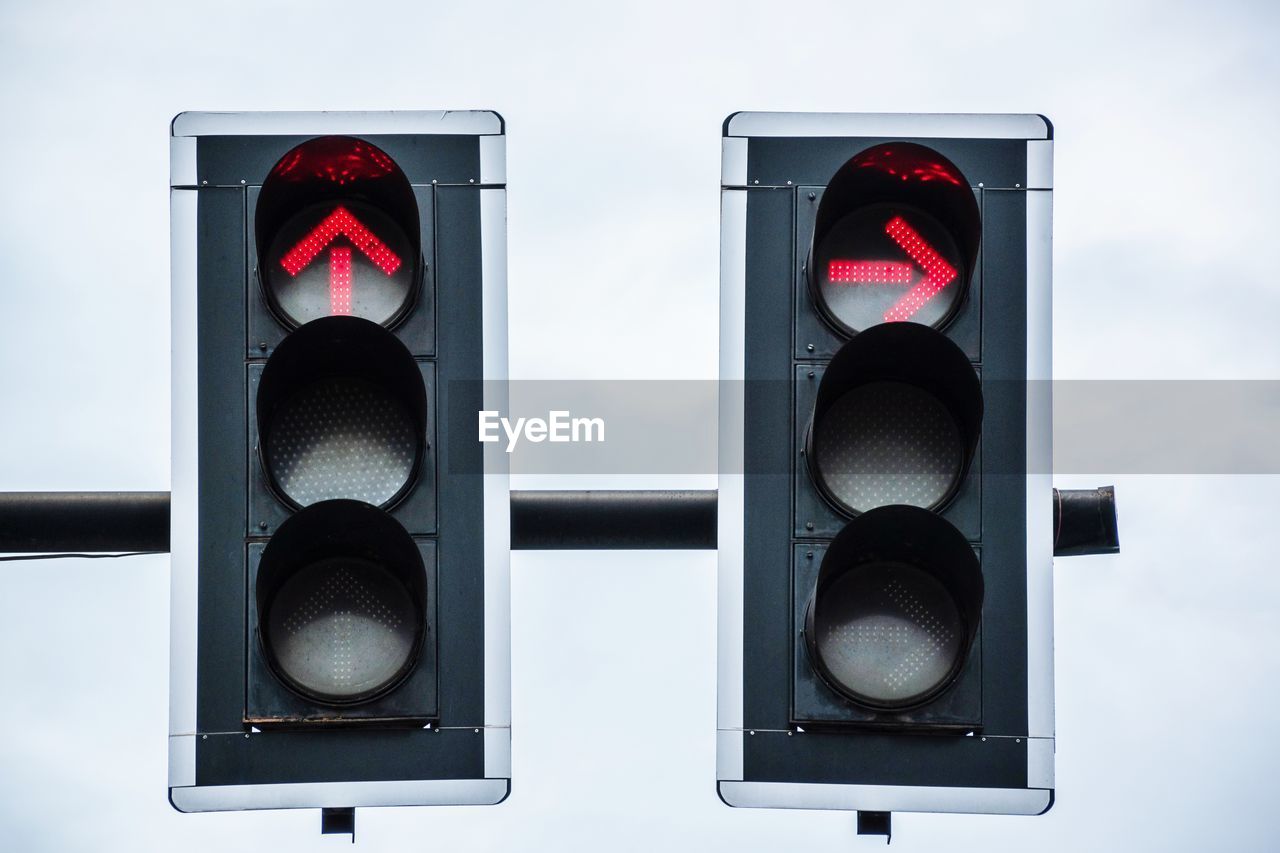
xmin=717 ymin=113 xmax=1053 ymax=809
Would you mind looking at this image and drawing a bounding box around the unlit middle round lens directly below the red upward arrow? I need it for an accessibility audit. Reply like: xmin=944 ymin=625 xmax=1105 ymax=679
xmin=264 ymin=377 xmax=419 ymax=506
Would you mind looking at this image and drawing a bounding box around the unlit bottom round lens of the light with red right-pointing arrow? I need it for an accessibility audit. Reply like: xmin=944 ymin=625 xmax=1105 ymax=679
xmin=814 ymin=562 xmax=964 ymax=706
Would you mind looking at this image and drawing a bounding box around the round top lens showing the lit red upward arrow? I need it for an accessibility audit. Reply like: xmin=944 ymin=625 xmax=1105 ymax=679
xmin=261 ymin=199 xmax=417 ymax=327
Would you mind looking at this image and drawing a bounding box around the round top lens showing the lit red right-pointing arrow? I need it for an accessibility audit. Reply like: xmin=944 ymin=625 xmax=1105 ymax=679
xmin=813 ymin=204 xmax=966 ymax=334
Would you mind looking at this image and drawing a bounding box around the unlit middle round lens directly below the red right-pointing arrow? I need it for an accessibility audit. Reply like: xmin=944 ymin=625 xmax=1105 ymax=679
xmin=813 ymin=382 xmax=964 ymax=512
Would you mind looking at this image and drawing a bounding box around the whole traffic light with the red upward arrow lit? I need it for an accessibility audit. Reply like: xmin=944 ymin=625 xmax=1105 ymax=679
xmin=169 ymin=111 xmax=511 ymax=811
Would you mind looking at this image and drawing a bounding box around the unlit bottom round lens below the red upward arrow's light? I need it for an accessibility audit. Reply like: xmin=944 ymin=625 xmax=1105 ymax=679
xmin=268 ymin=557 xmax=419 ymax=702
